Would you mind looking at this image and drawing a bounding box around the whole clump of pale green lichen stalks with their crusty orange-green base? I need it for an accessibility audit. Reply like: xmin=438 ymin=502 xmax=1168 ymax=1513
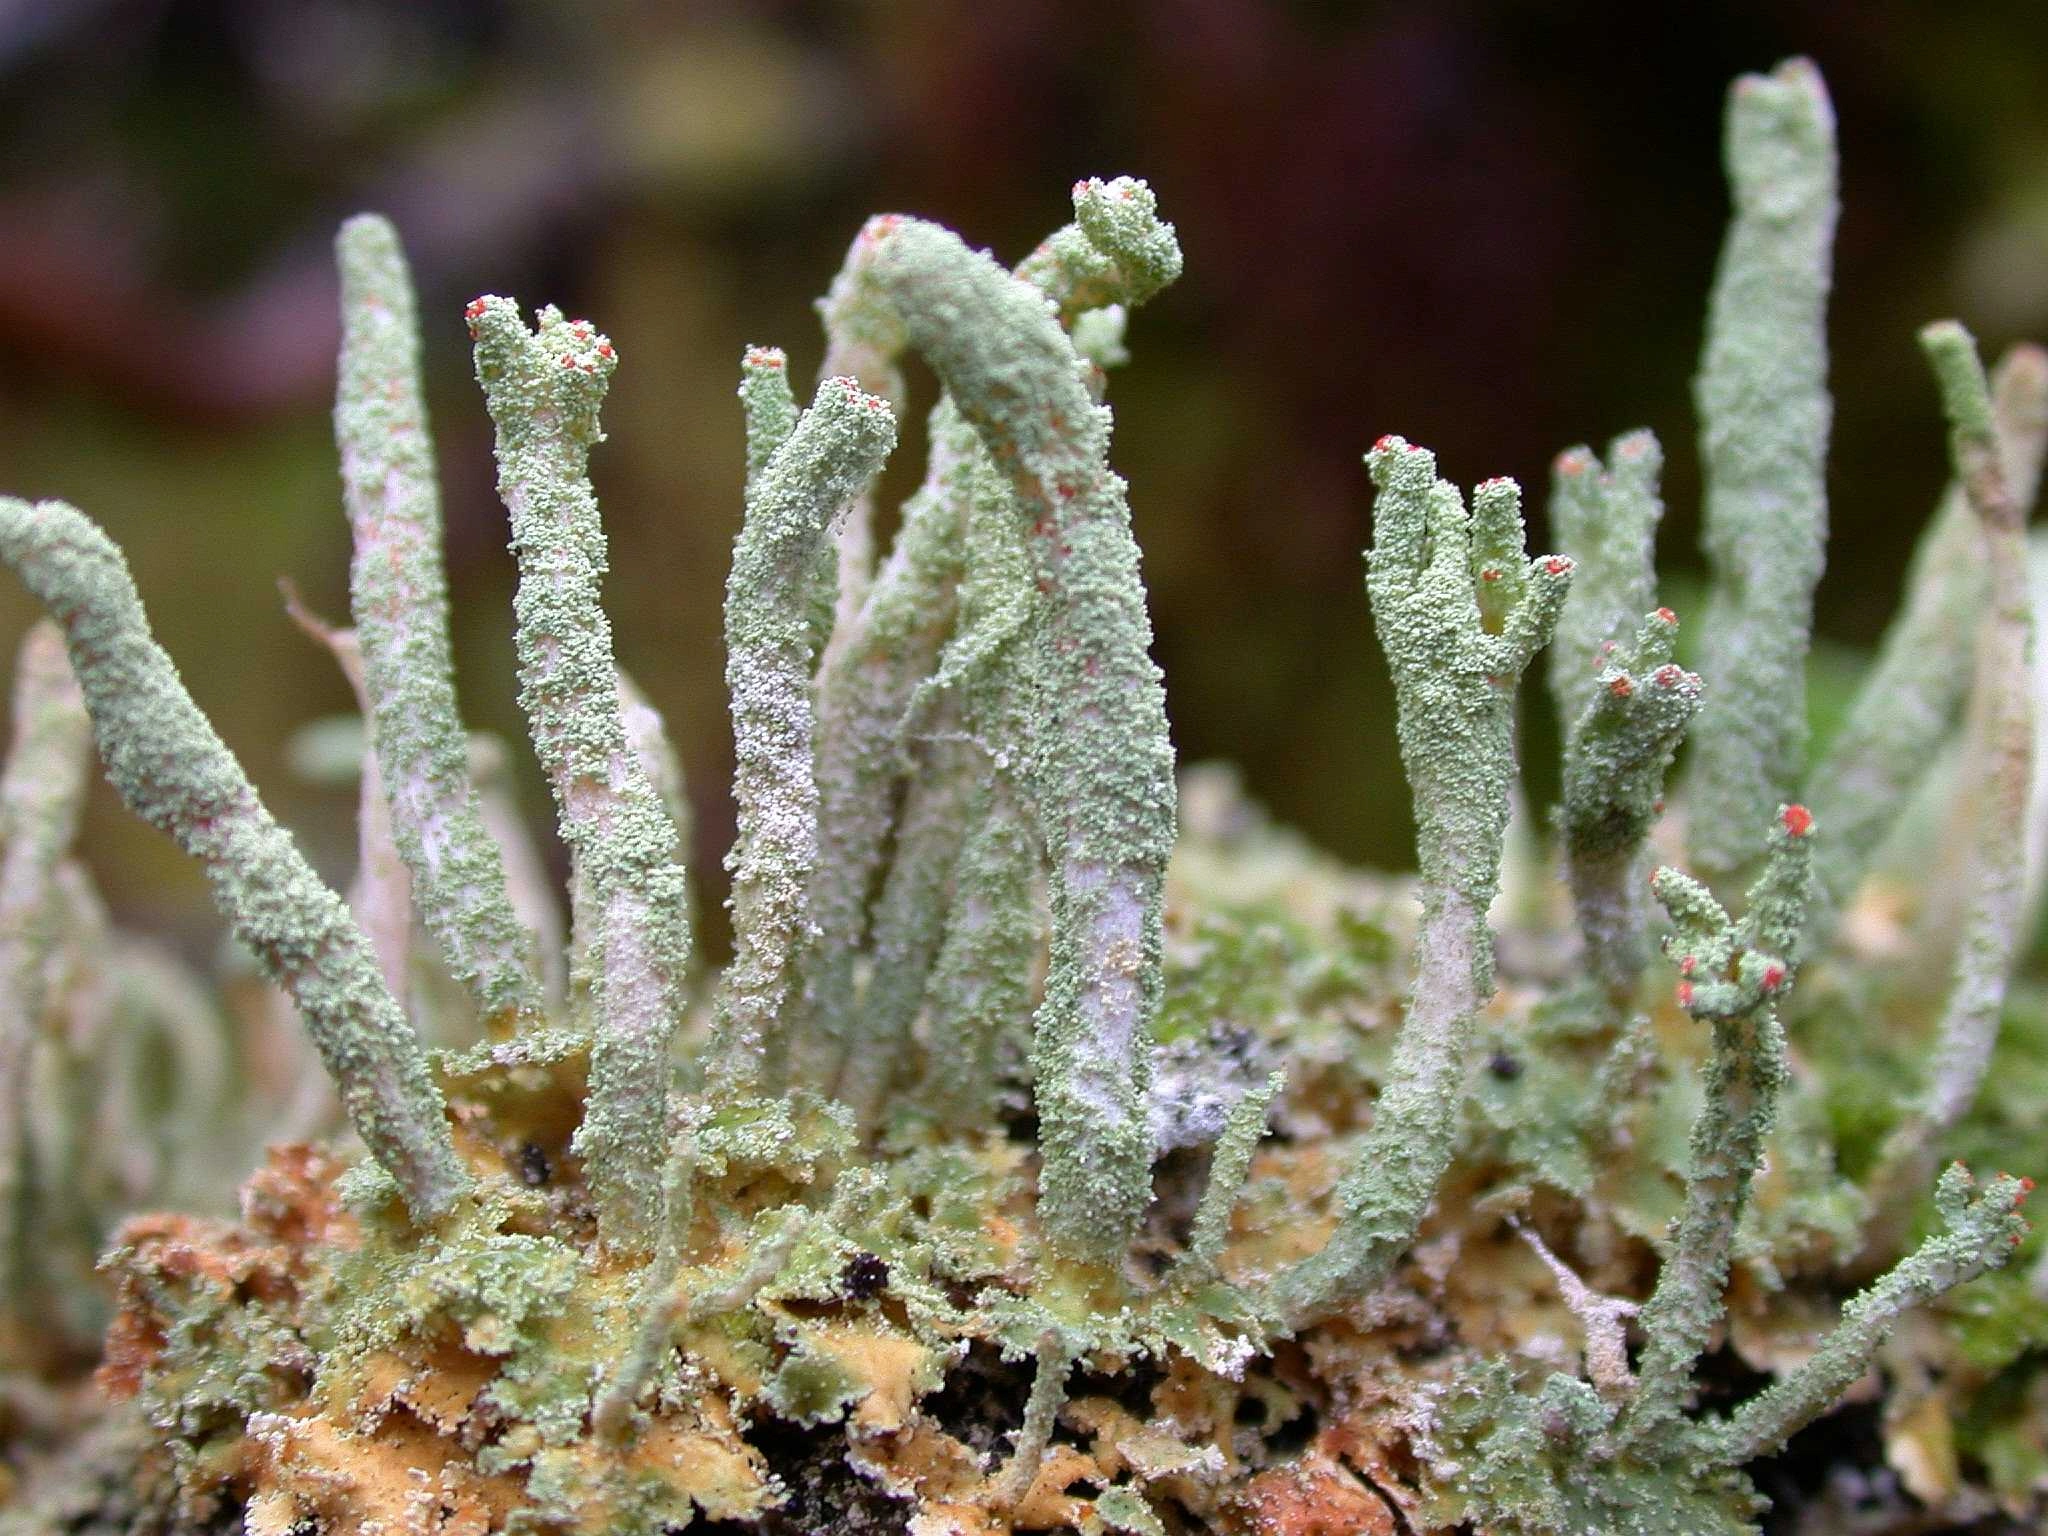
xmin=0 ymin=61 xmax=2048 ymax=1536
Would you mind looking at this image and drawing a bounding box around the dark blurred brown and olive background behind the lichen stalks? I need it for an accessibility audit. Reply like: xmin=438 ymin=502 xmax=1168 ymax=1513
xmin=0 ymin=0 xmax=2048 ymax=962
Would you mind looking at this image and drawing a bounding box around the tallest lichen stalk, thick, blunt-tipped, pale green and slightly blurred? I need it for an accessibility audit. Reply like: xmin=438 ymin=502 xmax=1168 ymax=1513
xmin=1686 ymin=59 xmax=1837 ymax=877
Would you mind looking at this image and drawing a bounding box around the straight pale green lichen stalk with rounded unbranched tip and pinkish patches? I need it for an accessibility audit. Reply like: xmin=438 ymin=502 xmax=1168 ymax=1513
xmin=334 ymin=215 xmax=543 ymax=1028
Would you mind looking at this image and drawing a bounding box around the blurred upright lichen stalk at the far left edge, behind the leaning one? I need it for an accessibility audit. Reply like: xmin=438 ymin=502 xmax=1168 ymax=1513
xmin=0 ymin=618 xmax=92 ymax=1309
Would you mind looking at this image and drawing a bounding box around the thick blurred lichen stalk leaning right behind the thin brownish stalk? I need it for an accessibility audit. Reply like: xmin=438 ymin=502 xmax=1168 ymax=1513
xmin=1806 ymin=346 xmax=2048 ymax=944
